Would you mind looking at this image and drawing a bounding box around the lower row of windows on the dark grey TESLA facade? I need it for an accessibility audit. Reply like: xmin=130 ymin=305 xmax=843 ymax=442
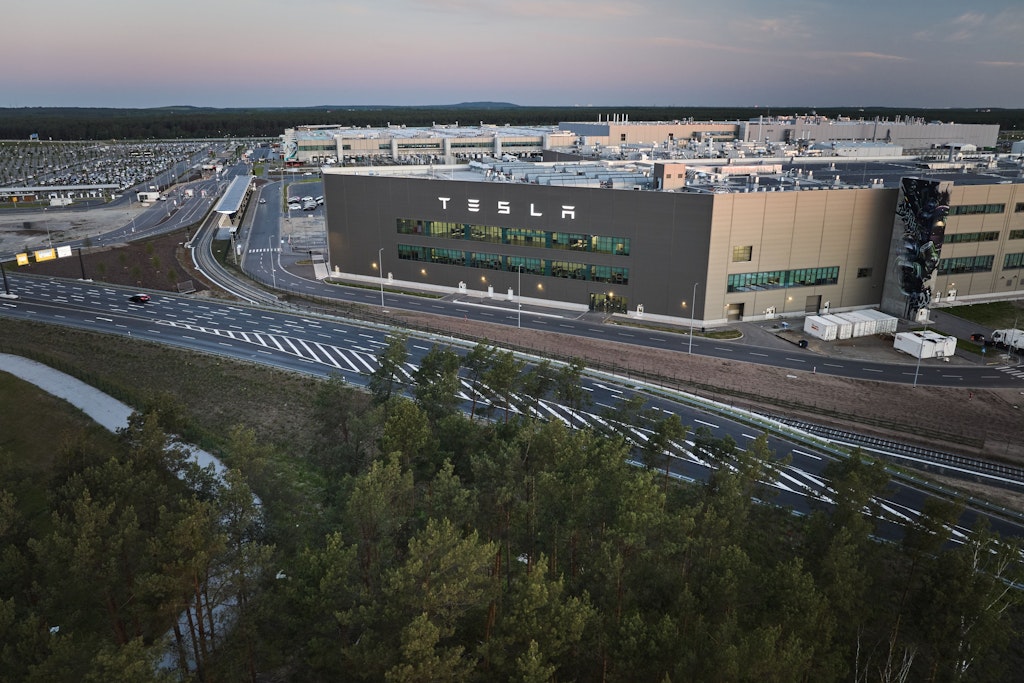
xmin=398 ymin=245 xmax=630 ymax=285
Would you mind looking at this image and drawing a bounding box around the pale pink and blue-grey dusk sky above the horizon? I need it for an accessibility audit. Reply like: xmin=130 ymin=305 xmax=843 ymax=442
xmin=0 ymin=0 xmax=1024 ymax=109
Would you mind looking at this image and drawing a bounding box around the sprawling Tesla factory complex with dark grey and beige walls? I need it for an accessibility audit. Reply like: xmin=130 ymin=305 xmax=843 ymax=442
xmin=311 ymin=117 xmax=1024 ymax=326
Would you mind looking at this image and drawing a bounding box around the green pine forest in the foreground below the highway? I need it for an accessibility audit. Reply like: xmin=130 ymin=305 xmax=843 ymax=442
xmin=0 ymin=335 xmax=1022 ymax=683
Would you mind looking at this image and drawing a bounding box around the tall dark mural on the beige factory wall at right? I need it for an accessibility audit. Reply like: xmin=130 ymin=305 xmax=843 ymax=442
xmin=882 ymin=178 xmax=952 ymax=321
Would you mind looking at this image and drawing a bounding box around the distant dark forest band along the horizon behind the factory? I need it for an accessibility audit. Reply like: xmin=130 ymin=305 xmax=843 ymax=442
xmin=0 ymin=102 xmax=1024 ymax=140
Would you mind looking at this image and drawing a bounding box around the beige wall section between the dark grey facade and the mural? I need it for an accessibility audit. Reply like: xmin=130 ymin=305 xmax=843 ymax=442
xmin=705 ymin=185 xmax=896 ymax=321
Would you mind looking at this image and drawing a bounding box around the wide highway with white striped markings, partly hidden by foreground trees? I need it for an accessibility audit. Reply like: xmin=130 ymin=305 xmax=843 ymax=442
xmin=0 ymin=274 xmax=1024 ymax=539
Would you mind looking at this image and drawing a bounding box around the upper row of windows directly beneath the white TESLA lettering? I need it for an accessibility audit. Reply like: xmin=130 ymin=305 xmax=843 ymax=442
xmin=397 ymin=218 xmax=630 ymax=256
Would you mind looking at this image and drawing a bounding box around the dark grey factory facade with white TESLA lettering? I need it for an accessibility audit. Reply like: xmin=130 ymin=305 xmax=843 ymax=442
xmin=324 ymin=173 xmax=714 ymax=317
